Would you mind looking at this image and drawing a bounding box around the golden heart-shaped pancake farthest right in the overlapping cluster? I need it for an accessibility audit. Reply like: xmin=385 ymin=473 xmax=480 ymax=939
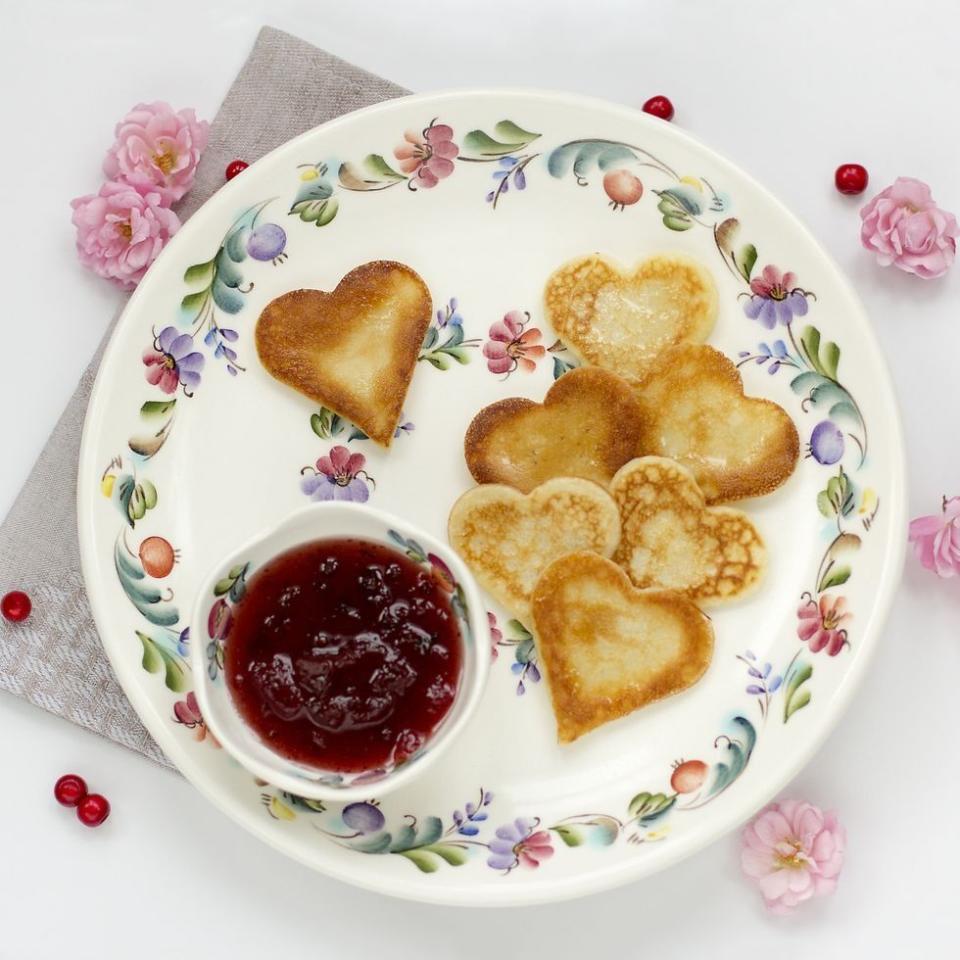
xmin=637 ymin=344 xmax=800 ymax=503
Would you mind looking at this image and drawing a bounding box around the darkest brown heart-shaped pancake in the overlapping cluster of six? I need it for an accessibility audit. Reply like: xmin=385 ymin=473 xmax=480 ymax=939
xmin=464 ymin=367 xmax=640 ymax=493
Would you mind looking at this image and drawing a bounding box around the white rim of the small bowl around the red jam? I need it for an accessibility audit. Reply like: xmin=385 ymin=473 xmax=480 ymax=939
xmin=190 ymin=501 xmax=490 ymax=803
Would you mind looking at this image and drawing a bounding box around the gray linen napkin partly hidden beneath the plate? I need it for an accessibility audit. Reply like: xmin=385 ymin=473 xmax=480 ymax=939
xmin=0 ymin=27 xmax=407 ymax=765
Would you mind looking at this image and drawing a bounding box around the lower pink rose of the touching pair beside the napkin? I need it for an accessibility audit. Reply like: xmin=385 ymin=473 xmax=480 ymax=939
xmin=70 ymin=181 xmax=180 ymax=290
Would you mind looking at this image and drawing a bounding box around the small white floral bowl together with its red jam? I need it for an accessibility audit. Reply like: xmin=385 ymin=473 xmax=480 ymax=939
xmin=192 ymin=503 xmax=490 ymax=801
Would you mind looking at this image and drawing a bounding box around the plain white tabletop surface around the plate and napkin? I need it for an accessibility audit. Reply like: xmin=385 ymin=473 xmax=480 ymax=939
xmin=0 ymin=0 xmax=960 ymax=960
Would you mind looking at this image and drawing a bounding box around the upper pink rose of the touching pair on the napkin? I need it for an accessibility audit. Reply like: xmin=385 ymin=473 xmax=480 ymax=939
xmin=103 ymin=100 xmax=209 ymax=206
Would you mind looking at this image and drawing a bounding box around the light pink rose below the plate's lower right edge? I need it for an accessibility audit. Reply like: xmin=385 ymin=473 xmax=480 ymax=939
xmin=740 ymin=800 xmax=847 ymax=913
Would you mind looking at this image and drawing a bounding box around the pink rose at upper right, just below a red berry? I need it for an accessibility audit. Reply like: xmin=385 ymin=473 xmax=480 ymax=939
xmin=860 ymin=177 xmax=960 ymax=279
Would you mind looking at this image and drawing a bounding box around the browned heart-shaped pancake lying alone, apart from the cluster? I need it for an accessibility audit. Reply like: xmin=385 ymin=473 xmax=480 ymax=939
xmin=256 ymin=260 xmax=432 ymax=447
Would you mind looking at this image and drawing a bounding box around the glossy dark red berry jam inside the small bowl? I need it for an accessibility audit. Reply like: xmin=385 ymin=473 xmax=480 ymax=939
xmin=225 ymin=539 xmax=462 ymax=773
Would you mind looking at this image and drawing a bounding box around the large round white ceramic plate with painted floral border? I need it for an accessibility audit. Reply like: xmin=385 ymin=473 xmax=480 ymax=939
xmin=79 ymin=91 xmax=904 ymax=905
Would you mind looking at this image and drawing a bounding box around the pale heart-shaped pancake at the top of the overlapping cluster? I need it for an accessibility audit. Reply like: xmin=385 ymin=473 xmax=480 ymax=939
xmin=544 ymin=254 xmax=717 ymax=385
